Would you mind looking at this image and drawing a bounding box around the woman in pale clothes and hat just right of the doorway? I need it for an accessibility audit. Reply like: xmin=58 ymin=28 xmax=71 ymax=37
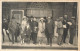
xmin=20 ymin=16 xmax=27 ymax=44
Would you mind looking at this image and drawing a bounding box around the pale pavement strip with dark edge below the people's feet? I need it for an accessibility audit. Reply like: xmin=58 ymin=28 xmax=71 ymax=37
xmin=2 ymin=42 xmax=78 ymax=50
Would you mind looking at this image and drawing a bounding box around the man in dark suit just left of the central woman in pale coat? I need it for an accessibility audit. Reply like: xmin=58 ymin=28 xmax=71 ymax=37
xmin=31 ymin=18 xmax=38 ymax=44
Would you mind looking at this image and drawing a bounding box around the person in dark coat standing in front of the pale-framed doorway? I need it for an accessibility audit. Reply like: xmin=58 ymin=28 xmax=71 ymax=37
xmin=9 ymin=17 xmax=17 ymax=44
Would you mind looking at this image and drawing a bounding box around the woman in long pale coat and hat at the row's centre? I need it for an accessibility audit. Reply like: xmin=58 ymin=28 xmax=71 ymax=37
xmin=37 ymin=18 xmax=45 ymax=44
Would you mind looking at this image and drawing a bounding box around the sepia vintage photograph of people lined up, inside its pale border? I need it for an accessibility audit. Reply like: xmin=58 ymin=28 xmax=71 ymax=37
xmin=1 ymin=2 xmax=78 ymax=50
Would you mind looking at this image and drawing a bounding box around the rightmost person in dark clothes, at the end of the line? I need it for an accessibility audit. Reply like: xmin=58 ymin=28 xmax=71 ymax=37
xmin=69 ymin=17 xmax=76 ymax=44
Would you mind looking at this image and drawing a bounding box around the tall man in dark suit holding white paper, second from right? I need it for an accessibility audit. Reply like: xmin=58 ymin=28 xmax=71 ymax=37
xmin=63 ymin=15 xmax=69 ymax=43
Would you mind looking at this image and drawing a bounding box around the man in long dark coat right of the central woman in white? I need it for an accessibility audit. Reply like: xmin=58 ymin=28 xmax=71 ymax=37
xmin=45 ymin=17 xmax=54 ymax=46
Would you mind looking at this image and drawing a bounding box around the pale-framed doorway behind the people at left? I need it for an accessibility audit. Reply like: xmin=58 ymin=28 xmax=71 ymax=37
xmin=10 ymin=10 xmax=24 ymax=24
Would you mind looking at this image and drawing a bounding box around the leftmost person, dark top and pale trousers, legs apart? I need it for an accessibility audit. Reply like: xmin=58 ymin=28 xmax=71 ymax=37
xmin=2 ymin=19 xmax=11 ymax=42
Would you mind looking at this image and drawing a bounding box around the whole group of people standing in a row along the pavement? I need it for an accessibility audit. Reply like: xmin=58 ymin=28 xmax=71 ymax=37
xmin=2 ymin=15 xmax=76 ymax=46
